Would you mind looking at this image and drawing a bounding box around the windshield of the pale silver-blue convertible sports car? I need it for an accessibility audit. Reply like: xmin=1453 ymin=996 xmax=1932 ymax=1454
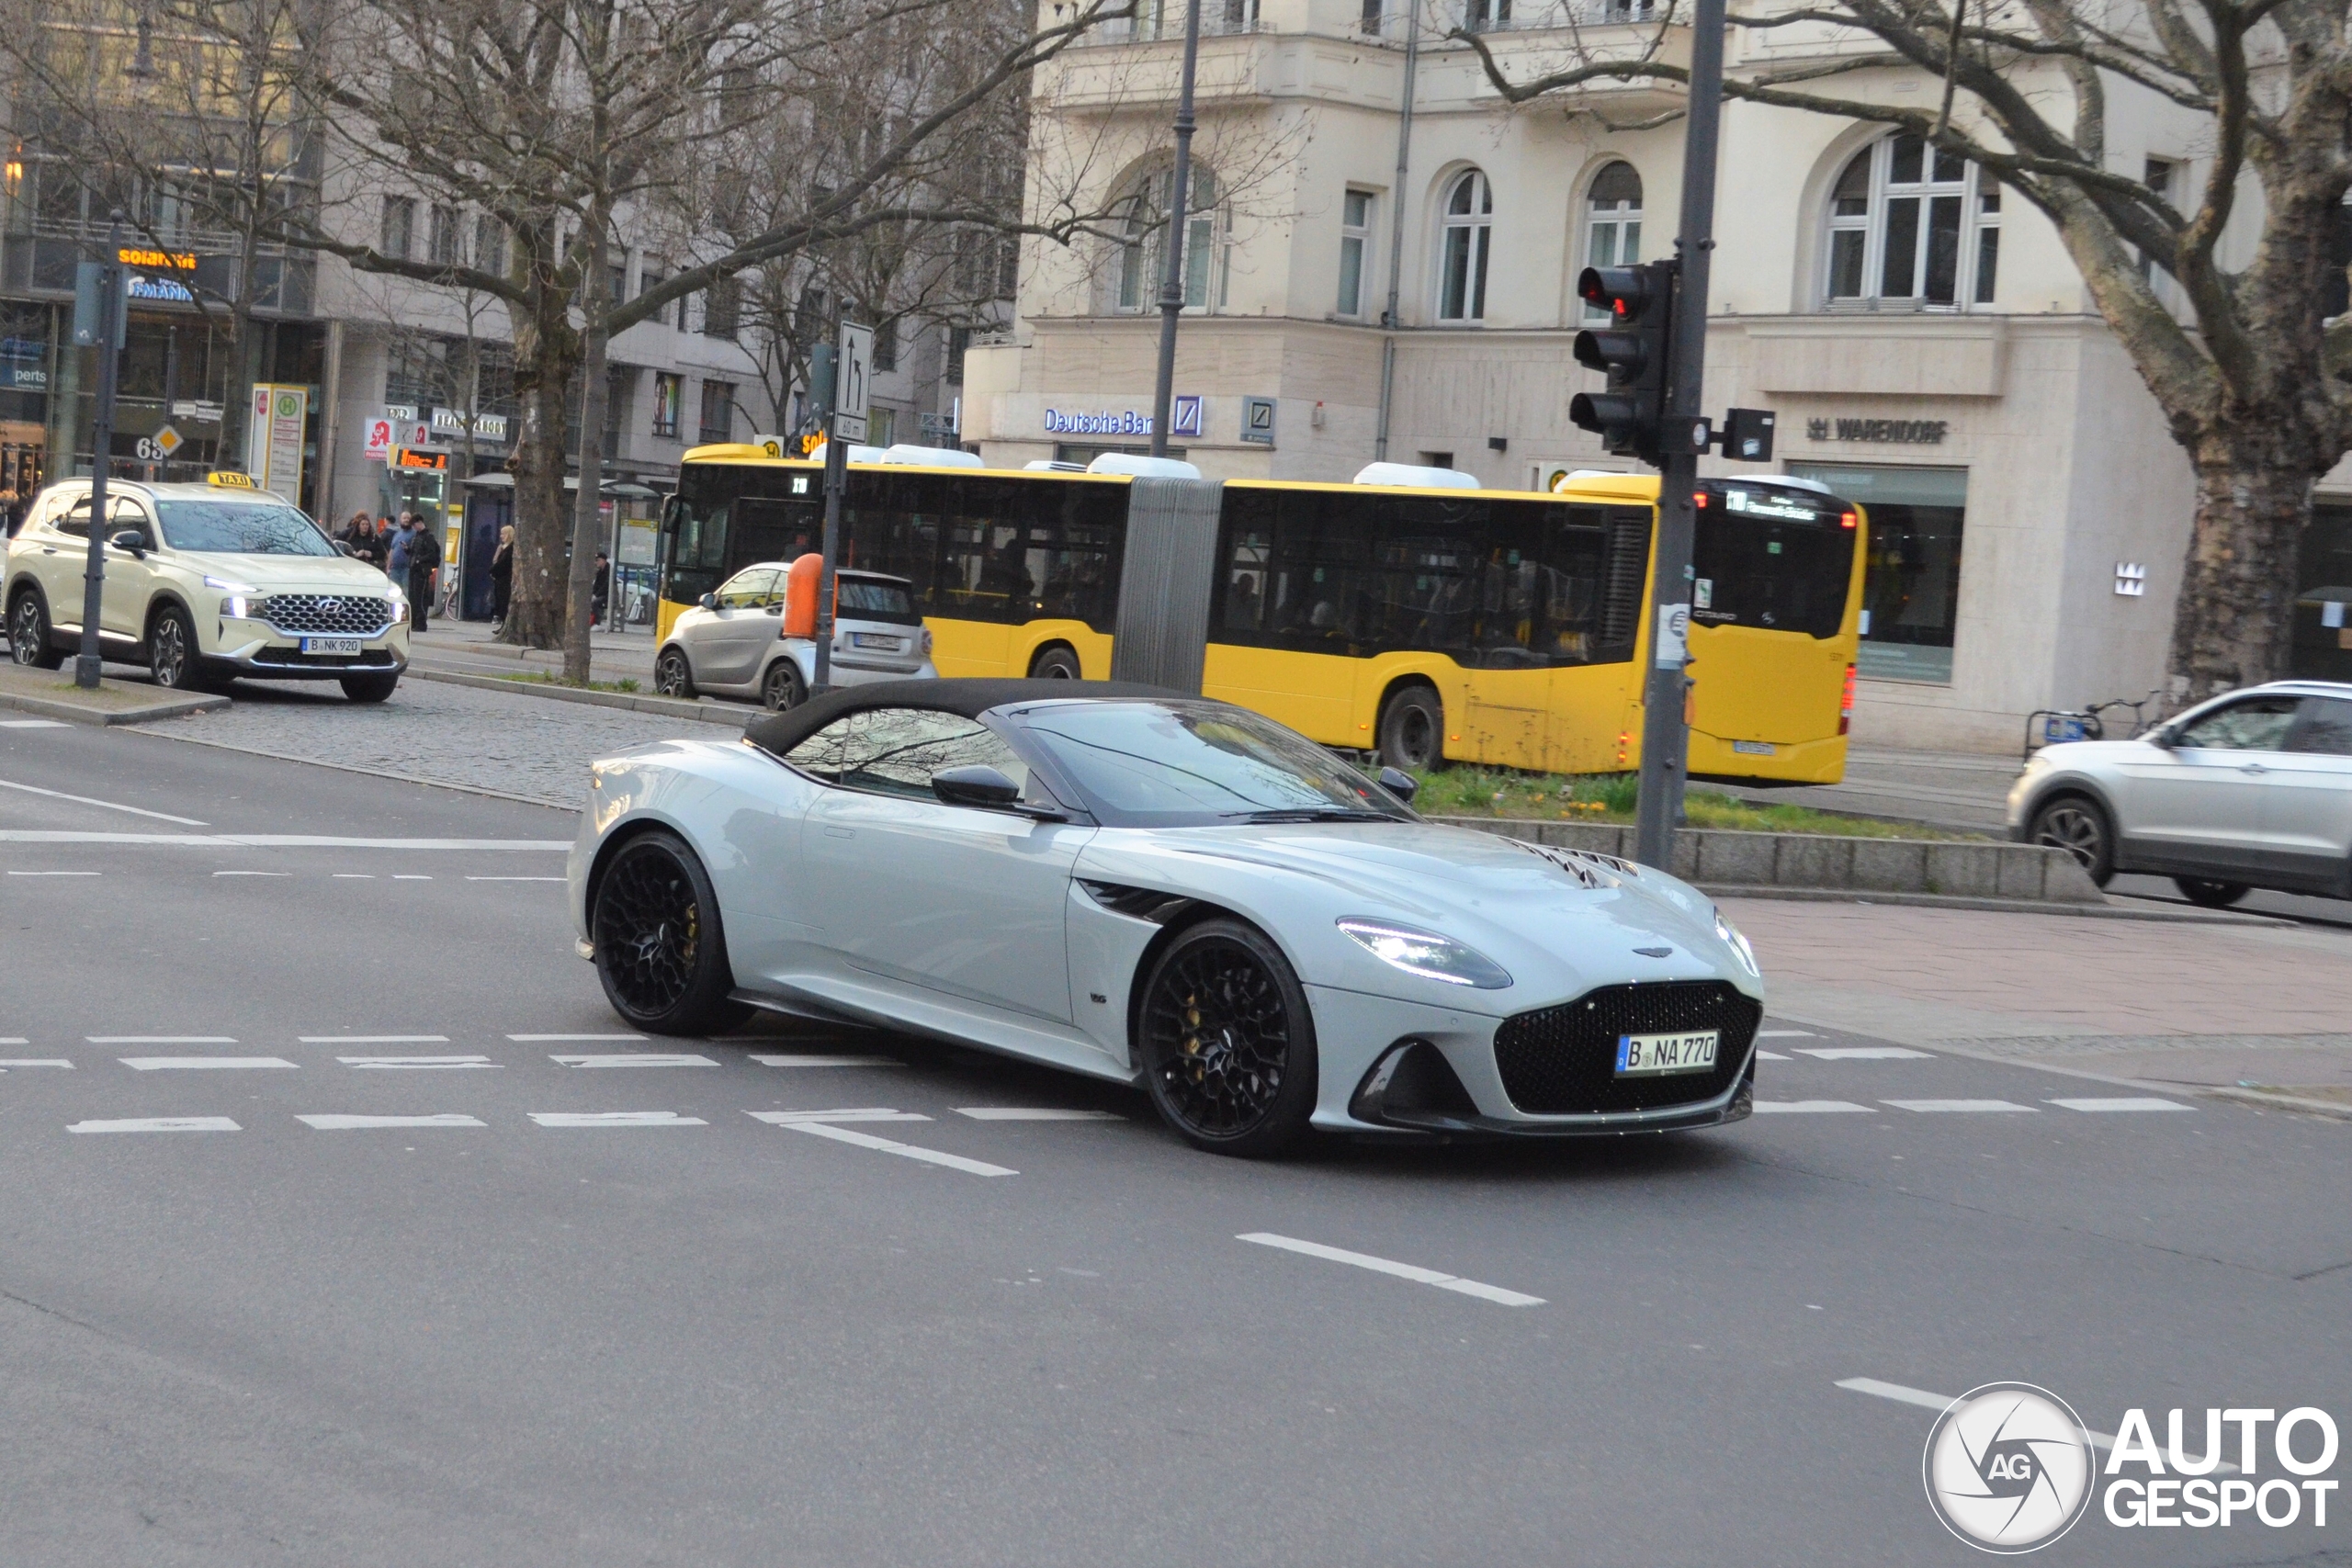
xmin=1021 ymin=701 xmax=1414 ymax=828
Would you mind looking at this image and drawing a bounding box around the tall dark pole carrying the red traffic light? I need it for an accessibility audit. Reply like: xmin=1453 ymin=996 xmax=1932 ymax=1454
xmin=1634 ymin=0 xmax=1724 ymax=872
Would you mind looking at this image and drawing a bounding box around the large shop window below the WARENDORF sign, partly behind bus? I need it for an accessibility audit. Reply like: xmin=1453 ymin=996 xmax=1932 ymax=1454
xmin=1788 ymin=463 xmax=1969 ymax=686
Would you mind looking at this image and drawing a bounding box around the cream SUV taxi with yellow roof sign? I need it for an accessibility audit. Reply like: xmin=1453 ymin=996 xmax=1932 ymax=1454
xmin=0 ymin=472 xmax=409 ymax=703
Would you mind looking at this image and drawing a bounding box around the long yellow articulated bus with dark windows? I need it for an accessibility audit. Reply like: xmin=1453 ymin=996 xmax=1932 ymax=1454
xmin=659 ymin=445 xmax=1863 ymax=783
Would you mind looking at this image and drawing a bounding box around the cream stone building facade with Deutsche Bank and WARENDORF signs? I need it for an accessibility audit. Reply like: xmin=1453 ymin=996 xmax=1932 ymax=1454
xmin=965 ymin=0 xmax=2352 ymax=750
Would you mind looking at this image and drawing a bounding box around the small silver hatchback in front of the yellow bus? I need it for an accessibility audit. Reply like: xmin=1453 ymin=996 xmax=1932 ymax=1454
xmin=654 ymin=562 xmax=938 ymax=707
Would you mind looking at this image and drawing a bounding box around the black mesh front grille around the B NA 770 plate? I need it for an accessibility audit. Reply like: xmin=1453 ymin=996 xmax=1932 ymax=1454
xmin=1494 ymin=980 xmax=1764 ymax=1117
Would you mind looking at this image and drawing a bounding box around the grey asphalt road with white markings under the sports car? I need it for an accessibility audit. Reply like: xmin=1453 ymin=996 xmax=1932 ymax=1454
xmin=0 ymin=724 xmax=2352 ymax=1568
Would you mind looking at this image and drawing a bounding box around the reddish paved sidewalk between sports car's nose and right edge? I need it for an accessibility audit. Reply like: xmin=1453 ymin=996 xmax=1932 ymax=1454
xmin=1724 ymin=898 xmax=2352 ymax=1100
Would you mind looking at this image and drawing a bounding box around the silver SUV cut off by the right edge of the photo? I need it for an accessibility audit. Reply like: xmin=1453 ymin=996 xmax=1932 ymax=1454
xmin=2008 ymin=682 xmax=2352 ymax=909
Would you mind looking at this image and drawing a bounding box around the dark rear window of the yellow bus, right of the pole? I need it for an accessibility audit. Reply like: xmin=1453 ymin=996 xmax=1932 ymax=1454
xmin=1691 ymin=482 xmax=1858 ymax=637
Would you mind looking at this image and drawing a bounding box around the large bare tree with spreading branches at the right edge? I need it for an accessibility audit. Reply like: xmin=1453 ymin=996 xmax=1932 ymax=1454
xmin=1452 ymin=0 xmax=2352 ymax=701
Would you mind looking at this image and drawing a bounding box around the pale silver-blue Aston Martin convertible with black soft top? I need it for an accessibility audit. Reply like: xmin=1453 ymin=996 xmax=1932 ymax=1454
xmin=570 ymin=680 xmax=1764 ymax=1155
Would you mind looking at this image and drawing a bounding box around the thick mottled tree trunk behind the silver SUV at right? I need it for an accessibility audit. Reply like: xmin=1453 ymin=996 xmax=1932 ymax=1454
xmin=2171 ymin=434 xmax=2312 ymax=707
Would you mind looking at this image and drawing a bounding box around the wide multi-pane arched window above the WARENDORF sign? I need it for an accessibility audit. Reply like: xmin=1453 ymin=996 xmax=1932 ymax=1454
xmin=1823 ymin=131 xmax=2002 ymax=310
